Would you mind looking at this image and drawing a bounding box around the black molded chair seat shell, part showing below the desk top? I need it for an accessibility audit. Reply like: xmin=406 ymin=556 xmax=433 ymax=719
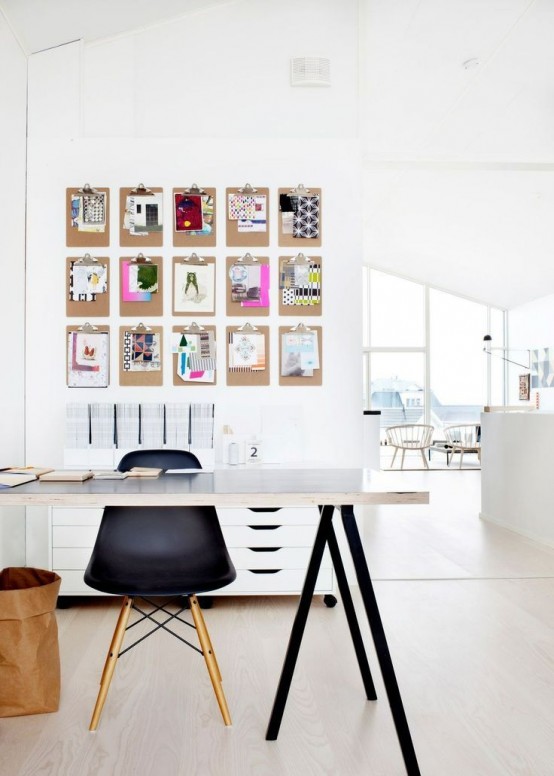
xmin=84 ymin=507 xmax=236 ymax=596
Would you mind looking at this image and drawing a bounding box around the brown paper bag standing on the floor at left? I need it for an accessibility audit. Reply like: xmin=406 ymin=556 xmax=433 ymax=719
xmin=0 ymin=568 xmax=61 ymax=717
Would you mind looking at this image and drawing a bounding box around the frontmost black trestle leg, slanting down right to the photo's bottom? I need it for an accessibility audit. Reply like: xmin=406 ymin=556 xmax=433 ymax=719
xmin=341 ymin=506 xmax=420 ymax=776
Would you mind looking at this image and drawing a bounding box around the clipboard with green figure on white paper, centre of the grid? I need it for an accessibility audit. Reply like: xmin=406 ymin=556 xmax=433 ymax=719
xmin=173 ymin=254 xmax=215 ymax=315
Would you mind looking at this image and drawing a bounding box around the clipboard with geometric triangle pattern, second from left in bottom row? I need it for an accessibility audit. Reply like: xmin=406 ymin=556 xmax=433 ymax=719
xmin=119 ymin=323 xmax=163 ymax=385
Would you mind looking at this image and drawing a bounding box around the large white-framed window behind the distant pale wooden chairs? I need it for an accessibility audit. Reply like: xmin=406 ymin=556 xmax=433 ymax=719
xmin=363 ymin=267 xmax=504 ymax=436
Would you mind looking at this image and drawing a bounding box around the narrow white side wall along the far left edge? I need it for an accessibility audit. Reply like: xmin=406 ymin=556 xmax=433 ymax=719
xmin=0 ymin=10 xmax=27 ymax=567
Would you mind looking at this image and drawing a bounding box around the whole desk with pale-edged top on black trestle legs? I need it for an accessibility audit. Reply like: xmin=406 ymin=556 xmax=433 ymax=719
xmin=0 ymin=467 xmax=429 ymax=776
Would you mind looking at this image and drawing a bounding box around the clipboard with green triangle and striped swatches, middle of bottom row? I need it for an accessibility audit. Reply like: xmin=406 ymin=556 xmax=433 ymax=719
xmin=171 ymin=323 xmax=216 ymax=385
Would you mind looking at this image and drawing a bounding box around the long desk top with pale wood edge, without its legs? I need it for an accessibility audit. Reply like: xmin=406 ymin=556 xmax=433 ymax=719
xmin=0 ymin=468 xmax=429 ymax=507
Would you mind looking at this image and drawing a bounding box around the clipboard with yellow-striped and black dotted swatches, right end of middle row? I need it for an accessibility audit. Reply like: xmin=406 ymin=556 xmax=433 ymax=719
xmin=278 ymin=253 xmax=322 ymax=317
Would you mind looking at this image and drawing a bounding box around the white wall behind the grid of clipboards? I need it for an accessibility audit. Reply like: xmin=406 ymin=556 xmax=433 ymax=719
xmin=27 ymin=0 xmax=362 ymax=466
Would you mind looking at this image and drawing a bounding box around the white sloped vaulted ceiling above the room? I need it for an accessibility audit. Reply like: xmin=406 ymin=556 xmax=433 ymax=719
xmin=0 ymin=0 xmax=554 ymax=307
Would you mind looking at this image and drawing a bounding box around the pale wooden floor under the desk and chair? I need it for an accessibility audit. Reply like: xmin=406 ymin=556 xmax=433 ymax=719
xmin=0 ymin=471 xmax=554 ymax=776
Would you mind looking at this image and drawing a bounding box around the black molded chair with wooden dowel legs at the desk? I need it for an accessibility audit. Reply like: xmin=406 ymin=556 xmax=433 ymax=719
xmin=85 ymin=450 xmax=236 ymax=730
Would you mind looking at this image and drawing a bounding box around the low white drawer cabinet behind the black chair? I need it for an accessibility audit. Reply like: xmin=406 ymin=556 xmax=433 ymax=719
xmin=50 ymin=507 xmax=335 ymax=605
